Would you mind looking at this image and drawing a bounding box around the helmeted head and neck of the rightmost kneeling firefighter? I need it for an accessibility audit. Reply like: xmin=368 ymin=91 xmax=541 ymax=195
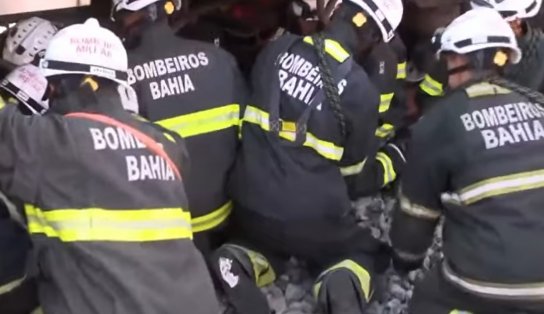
xmin=433 ymin=8 xmax=522 ymax=89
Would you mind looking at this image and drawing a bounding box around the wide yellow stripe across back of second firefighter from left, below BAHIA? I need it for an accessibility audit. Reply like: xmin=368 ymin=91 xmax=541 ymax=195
xmin=157 ymin=104 xmax=240 ymax=138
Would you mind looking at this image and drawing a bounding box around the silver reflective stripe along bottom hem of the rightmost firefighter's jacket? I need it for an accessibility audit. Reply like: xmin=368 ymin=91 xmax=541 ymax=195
xmin=442 ymin=261 xmax=544 ymax=299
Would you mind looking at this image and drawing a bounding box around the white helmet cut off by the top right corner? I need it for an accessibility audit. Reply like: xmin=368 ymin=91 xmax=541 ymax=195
xmin=471 ymin=0 xmax=542 ymax=22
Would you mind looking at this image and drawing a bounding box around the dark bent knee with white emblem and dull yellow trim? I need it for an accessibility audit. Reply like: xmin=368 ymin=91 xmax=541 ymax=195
xmin=212 ymin=244 xmax=276 ymax=287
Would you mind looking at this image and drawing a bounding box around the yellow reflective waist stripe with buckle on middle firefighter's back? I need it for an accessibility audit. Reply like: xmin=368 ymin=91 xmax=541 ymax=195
xmin=244 ymin=106 xmax=344 ymax=161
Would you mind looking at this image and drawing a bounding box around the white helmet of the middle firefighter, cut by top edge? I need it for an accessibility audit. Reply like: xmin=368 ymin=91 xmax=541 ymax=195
xmin=344 ymin=0 xmax=404 ymax=42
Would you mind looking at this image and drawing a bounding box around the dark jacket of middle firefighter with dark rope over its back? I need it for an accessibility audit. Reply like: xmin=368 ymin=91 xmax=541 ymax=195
xmin=231 ymin=27 xmax=404 ymax=222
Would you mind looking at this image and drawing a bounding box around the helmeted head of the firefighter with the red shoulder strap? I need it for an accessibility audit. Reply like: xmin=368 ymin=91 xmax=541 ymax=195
xmin=40 ymin=18 xmax=128 ymax=112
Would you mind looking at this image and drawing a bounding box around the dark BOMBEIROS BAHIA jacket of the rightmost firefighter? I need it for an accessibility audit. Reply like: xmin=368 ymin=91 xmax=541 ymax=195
xmin=391 ymin=83 xmax=544 ymax=298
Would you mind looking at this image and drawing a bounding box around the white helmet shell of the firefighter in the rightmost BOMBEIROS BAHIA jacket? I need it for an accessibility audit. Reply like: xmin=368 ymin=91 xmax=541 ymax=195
xmin=437 ymin=8 xmax=521 ymax=63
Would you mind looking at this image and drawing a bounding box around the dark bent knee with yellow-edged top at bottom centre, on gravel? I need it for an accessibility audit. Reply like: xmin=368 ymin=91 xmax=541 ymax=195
xmin=313 ymin=260 xmax=373 ymax=314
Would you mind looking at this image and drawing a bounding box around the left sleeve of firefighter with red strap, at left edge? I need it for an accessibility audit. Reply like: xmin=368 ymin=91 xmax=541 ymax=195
xmin=0 ymin=106 xmax=43 ymax=205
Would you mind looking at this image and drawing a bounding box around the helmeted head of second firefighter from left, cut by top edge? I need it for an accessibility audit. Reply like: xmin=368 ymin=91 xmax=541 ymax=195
xmin=110 ymin=0 xmax=182 ymax=47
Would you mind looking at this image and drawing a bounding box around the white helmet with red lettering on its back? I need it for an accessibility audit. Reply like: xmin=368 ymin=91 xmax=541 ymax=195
xmin=40 ymin=18 xmax=128 ymax=84
